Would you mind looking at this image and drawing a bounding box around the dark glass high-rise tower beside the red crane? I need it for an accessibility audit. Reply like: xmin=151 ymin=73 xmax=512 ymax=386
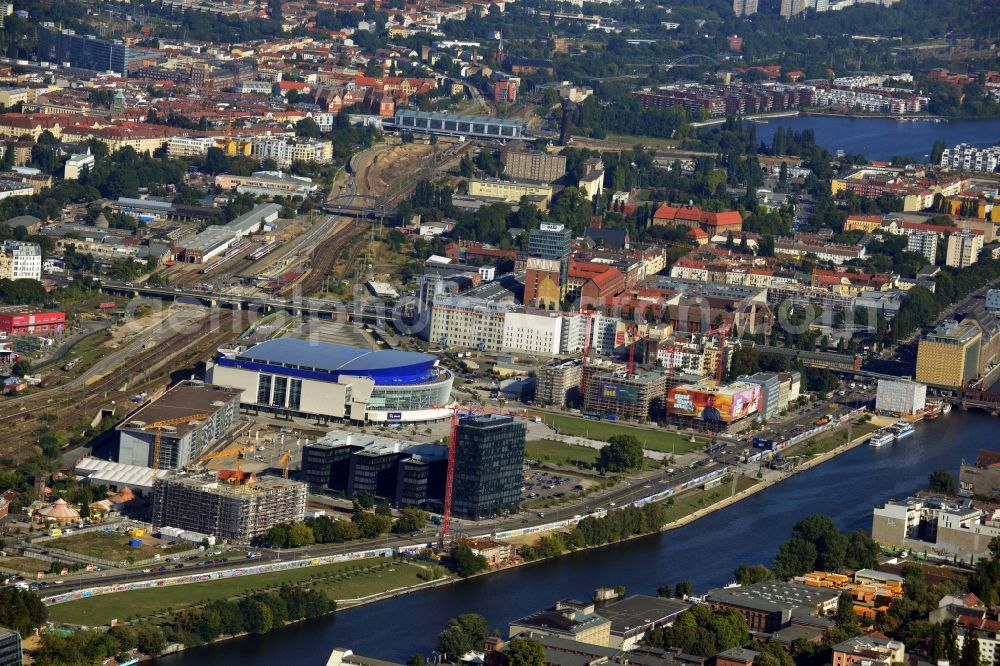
xmin=452 ymin=414 xmax=528 ymax=520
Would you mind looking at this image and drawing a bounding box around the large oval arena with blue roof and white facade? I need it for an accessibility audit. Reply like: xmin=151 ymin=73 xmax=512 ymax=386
xmin=208 ymin=338 xmax=454 ymax=423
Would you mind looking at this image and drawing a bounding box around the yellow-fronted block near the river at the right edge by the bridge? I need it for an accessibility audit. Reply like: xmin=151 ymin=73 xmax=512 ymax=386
xmin=916 ymin=319 xmax=983 ymax=388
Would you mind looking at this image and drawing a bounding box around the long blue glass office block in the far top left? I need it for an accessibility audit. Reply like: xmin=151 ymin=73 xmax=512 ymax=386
xmin=38 ymin=23 xmax=153 ymax=76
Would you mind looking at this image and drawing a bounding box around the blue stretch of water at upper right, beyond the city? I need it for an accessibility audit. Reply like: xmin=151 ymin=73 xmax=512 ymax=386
xmin=757 ymin=116 xmax=1000 ymax=160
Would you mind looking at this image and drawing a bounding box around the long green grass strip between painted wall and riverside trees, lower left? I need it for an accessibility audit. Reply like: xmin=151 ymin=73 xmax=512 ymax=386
xmin=49 ymin=558 xmax=434 ymax=626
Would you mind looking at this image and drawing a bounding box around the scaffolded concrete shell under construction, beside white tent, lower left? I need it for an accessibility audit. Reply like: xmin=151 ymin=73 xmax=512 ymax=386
xmin=152 ymin=470 xmax=307 ymax=543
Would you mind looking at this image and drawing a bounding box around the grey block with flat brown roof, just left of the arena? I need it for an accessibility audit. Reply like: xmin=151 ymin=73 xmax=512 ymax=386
xmin=116 ymin=380 xmax=240 ymax=469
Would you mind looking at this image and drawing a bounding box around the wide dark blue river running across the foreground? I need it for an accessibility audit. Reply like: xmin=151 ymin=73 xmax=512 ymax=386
xmin=157 ymin=411 xmax=1000 ymax=666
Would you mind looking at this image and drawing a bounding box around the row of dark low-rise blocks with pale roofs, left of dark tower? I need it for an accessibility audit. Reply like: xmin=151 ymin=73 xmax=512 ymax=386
xmin=302 ymin=432 xmax=448 ymax=508
